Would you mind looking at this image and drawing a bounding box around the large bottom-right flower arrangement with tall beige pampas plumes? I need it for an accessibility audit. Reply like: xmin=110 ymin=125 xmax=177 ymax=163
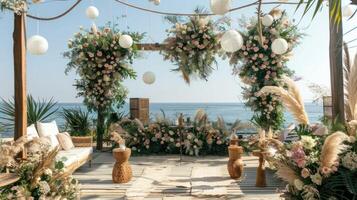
xmin=258 ymin=71 xmax=357 ymax=200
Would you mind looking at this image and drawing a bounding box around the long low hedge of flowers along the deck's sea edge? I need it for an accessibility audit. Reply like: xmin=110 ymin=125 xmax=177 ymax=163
xmin=111 ymin=110 xmax=249 ymax=156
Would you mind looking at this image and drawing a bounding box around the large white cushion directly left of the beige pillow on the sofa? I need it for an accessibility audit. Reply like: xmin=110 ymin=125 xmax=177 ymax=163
xmin=37 ymin=121 xmax=59 ymax=148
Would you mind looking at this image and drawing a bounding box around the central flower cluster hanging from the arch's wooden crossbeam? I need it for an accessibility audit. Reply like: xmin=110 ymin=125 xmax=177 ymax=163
xmin=161 ymin=10 xmax=224 ymax=83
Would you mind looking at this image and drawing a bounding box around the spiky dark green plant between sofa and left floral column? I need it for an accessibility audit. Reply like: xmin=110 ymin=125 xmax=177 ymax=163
xmin=61 ymin=108 xmax=92 ymax=136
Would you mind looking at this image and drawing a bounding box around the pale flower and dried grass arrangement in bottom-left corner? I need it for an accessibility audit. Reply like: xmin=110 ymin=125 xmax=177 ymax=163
xmin=0 ymin=138 xmax=79 ymax=199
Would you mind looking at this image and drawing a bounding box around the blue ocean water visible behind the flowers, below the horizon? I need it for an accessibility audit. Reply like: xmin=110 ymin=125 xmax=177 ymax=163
xmin=0 ymin=103 xmax=323 ymax=137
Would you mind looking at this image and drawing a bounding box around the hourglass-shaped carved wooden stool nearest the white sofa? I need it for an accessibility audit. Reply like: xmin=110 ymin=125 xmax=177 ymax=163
xmin=112 ymin=148 xmax=133 ymax=183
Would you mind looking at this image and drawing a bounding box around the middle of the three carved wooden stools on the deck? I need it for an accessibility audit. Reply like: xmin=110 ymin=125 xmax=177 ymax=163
xmin=227 ymin=139 xmax=243 ymax=179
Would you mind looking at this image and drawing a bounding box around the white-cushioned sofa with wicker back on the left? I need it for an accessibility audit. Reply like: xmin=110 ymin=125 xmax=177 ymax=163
xmin=27 ymin=121 xmax=93 ymax=173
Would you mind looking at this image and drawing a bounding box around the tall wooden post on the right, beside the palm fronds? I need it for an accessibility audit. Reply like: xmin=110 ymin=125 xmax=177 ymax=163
xmin=329 ymin=0 xmax=345 ymax=122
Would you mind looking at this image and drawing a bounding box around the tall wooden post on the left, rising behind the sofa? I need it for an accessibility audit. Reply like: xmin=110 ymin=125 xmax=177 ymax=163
xmin=13 ymin=14 xmax=27 ymax=146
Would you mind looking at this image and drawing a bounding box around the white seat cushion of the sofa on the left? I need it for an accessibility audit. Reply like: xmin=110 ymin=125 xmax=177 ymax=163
xmin=56 ymin=147 xmax=93 ymax=167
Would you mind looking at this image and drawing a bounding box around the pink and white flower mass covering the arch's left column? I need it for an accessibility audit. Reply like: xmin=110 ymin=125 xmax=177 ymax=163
xmin=64 ymin=26 xmax=143 ymax=110
